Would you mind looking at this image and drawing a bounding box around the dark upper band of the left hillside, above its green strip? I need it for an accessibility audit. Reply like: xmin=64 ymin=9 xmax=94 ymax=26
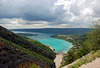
xmin=0 ymin=26 xmax=55 ymax=60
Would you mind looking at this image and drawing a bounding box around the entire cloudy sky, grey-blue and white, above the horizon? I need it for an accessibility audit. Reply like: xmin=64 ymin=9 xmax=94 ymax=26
xmin=0 ymin=0 xmax=100 ymax=29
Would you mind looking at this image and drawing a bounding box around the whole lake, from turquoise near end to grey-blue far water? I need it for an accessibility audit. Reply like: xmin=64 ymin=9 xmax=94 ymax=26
xmin=15 ymin=32 xmax=72 ymax=53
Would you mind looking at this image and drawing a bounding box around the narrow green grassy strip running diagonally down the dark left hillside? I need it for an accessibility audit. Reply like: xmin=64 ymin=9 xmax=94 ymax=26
xmin=0 ymin=37 xmax=53 ymax=64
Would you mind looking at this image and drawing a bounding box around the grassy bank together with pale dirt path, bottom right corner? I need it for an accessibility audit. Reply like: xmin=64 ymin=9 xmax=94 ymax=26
xmin=62 ymin=50 xmax=100 ymax=68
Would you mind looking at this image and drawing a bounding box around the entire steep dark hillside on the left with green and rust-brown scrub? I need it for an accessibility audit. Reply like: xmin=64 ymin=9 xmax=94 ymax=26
xmin=0 ymin=26 xmax=55 ymax=68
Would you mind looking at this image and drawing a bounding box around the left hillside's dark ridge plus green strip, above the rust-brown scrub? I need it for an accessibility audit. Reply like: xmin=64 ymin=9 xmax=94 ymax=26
xmin=0 ymin=26 xmax=55 ymax=67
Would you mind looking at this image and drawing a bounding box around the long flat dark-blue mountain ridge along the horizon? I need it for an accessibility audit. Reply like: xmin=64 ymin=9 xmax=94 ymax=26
xmin=11 ymin=28 xmax=91 ymax=34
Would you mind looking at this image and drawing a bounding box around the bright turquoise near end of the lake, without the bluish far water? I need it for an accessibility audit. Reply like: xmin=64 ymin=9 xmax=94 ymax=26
xmin=38 ymin=38 xmax=72 ymax=53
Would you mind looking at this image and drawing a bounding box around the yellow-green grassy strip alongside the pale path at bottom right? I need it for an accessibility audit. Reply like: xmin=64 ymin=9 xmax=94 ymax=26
xmin=68 ymin=50 xmax=100 ymax=68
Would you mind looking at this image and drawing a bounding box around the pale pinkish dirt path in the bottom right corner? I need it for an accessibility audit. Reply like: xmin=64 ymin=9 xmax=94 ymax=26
xmin=79 ymin=58 xmax=100 ymax=68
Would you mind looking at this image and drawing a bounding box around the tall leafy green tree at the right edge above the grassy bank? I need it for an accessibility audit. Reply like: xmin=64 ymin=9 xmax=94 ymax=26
xmin=87 ymin=19 xmax=100 ymax=50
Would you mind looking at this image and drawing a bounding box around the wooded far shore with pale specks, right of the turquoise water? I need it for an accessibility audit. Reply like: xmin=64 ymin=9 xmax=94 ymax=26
xmin=51 ymin=34 xmax=87 ymax=46
